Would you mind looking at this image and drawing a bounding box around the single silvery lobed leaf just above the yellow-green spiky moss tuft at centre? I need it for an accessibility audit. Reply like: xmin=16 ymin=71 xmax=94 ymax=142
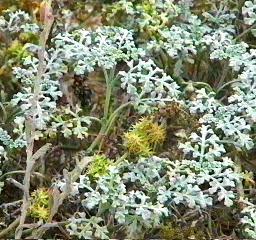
xmin=119 ymin=59 xmax=180 ymax=113
